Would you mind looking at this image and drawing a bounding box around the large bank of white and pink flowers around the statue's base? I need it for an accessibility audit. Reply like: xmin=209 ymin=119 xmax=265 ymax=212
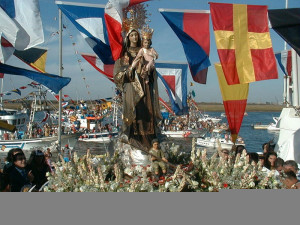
xmin=45 ymin=140 xmax=283 ymax=192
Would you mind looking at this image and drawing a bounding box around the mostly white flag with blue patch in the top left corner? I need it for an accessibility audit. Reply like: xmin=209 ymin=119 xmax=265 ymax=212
xmin=0 ymin=0 xmax=44 ymax=50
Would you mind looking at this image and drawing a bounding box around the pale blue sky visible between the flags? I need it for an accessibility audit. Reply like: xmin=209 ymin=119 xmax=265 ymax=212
xmin=4 ymin=0 xmax=300 ymax=103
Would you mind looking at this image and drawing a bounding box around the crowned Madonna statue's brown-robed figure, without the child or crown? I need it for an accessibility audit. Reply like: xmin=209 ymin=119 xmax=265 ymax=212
xmin=114 ymin=28 xmax=161 ymax=149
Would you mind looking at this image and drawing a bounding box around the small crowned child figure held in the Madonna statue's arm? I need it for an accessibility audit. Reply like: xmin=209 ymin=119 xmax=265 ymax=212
xmin=131 ymin=38 xmax=158 ymax=84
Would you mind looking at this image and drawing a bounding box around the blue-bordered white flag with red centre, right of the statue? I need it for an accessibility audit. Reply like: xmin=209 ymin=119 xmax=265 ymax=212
xmin=155 ymin=62 xmax=188 ymax=115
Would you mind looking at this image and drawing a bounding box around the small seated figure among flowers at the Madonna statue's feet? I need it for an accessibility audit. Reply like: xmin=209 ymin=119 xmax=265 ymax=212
xmin=149 ymin=139 xmax=168 ymax=179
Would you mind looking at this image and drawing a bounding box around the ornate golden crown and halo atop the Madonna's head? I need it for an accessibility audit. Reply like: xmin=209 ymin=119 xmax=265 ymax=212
xmin=122 ymin=4 xmax=147 ymax=34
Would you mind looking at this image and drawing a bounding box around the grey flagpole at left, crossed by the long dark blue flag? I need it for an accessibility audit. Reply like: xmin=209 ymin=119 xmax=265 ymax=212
xmin=58 ymin=9 xmax=62 ymax=151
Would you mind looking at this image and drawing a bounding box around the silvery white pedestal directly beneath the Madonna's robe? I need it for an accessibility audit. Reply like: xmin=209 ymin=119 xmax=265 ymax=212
xmin=114 ymin=136 xmax=151 ymax=167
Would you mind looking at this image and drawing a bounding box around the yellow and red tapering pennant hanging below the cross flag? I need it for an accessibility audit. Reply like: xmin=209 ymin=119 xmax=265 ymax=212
xmin=215 ymin=63 xmax=249 ymax=143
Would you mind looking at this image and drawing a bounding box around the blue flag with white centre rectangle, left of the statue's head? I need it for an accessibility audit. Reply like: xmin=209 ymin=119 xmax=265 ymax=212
xmin=56 ymin=1 xmax=114 ymax=64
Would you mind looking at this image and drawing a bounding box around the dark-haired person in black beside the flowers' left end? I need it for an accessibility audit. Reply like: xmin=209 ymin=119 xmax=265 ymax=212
xmin=28 ymin=150 xmax=51 ymax=189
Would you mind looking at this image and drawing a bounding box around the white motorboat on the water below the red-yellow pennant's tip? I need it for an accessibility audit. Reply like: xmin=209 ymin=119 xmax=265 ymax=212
xmin=196 ymin=131 xmax=245 ymax=149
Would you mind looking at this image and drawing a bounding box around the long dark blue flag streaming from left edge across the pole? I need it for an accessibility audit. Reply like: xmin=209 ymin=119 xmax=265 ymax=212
xmin=0 ymin=63 xmax=71 ymax=93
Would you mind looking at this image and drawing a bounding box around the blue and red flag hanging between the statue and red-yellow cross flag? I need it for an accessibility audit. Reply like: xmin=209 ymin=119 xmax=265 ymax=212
xmin=159 ymin=9 xmax=211 ymax=84
